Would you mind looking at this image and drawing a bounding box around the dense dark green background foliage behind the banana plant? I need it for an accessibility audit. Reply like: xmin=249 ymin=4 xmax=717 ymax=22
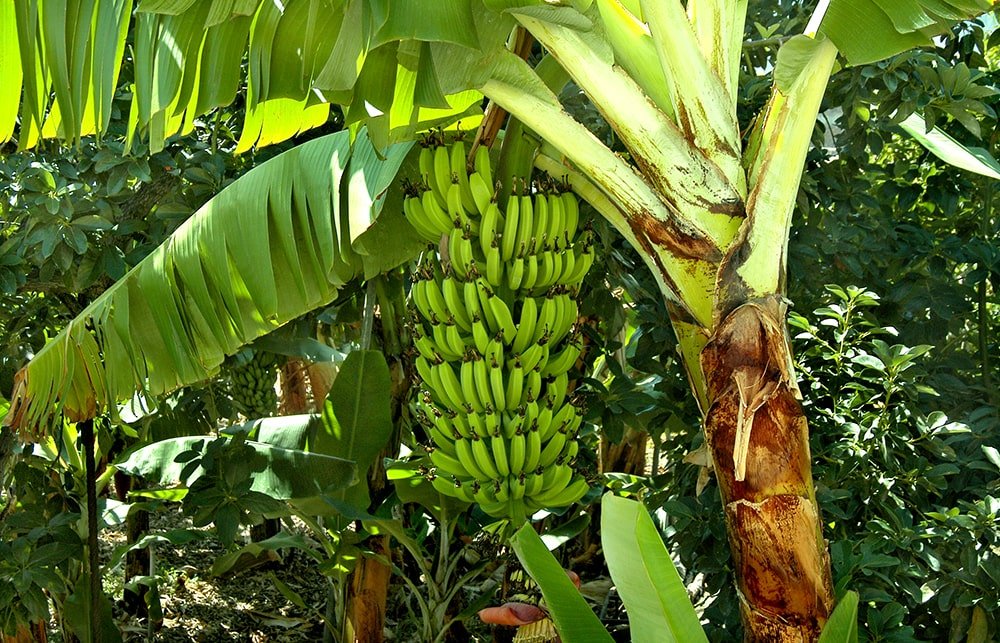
xmin=0 ymin=1 xmax=1000 ymax=641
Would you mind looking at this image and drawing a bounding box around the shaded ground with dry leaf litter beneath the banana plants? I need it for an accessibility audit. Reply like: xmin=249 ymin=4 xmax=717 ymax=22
xmin=41 ymin=511 xmax=627 ymax=643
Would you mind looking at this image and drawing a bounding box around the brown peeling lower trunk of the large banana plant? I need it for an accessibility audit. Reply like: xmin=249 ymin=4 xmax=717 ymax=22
xmin=701 ymin=296 xmax=834 ymax=641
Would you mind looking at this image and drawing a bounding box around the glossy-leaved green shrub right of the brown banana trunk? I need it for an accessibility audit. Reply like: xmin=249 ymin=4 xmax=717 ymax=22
xmin=790 ymin=286 xmax=1000 ymax=641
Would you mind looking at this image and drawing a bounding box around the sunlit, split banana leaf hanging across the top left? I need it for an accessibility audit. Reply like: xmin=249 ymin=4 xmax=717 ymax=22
xmin=0 ymin=0 xmax=492 ymax=151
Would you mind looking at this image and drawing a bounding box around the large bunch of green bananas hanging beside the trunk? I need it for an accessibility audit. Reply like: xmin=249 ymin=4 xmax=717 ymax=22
xmin=404 ymin=141 xmax=593 ymax=522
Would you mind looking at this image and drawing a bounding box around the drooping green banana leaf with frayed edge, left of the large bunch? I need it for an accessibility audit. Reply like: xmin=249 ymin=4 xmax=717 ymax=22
xmin=6 ymin=132 xmax=422 ymax=436
